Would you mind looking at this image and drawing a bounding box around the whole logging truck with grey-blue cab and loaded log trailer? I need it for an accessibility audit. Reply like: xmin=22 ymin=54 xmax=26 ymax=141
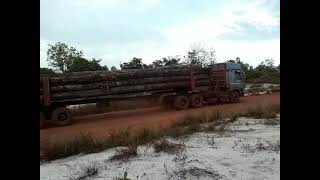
xmin=40 ymin=63 xmax=245 ymax=128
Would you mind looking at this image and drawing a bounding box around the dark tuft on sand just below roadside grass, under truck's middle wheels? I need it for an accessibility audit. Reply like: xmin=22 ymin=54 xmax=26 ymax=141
xmin=153 ymin=138 xmax=184 ymax=154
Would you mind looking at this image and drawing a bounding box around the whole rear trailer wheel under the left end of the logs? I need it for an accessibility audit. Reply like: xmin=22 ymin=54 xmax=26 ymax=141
xmin=51 ymin=107 xmax=71 ymax=126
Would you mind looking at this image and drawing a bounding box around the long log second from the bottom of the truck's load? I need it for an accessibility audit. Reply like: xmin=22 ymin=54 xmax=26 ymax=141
xmin=40 ymin=75 xmax=208 ymax=93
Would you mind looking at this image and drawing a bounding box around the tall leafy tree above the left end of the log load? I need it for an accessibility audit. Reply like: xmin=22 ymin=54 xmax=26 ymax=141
xmin=47 ymin=42 xmax=83 ymax=72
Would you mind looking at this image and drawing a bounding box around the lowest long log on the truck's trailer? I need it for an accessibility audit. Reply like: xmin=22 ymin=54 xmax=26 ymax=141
xmin=52 ymin=80 xmax=209 ymax=100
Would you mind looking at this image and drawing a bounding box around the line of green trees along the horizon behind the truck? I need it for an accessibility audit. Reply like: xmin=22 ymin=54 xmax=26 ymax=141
xmin=40 ymin=42 xmax=280 ymax=83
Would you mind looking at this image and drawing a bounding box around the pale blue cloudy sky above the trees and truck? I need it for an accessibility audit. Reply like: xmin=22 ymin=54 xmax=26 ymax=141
xmin=40 ymin=0 xmax=280 ymax=67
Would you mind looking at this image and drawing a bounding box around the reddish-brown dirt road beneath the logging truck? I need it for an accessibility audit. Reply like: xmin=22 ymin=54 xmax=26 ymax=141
xmin=40 ymin=94 xmax=280 ymax=148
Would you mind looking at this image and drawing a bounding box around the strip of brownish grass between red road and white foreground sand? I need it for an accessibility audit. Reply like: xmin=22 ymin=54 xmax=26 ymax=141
xmin=42 ymin=104 xmax=280 ymax=160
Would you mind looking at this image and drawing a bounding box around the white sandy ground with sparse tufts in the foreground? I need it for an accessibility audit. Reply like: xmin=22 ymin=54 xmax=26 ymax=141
xmin=40 ymin=116 xmax=280 ymax=180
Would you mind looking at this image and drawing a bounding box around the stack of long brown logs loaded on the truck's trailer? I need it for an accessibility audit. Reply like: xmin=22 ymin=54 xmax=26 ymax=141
xmin=40 ymin=66 xmax=209 ymax=100
